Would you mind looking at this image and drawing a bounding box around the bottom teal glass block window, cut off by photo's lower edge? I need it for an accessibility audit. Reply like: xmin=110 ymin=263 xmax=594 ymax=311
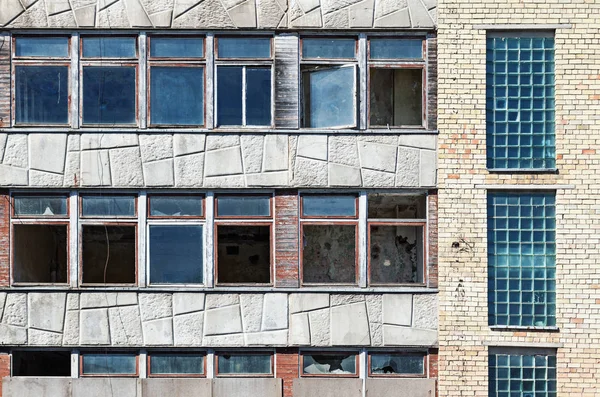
xmin=489 ymin=354 xmax=556 ymax=397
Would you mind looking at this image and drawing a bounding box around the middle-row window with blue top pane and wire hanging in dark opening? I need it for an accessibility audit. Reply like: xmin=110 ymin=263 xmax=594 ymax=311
xmin=80 ymin=194 xmax=137 ymax=285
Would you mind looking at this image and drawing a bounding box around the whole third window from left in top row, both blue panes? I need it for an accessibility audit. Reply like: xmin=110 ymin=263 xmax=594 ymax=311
xmin=148 ymin=36 xmax=205 ymax=126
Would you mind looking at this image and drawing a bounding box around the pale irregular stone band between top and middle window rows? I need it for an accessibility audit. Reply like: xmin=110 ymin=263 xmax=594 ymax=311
xmin=0 ymin=131 xmax=436 ymax=188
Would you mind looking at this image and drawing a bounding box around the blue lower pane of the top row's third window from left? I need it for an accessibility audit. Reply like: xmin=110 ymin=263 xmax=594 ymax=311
xmin=150 ymin=66 xmax=204 ymax=125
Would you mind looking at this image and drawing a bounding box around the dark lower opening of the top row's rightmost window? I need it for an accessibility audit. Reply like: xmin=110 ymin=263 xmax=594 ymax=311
xmin=369 ymin=68 xmax=423 ymax=127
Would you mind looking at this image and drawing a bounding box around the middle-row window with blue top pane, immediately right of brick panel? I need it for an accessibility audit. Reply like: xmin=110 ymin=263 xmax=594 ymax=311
xmin=301 ymin=194 xmax=358 ymax=284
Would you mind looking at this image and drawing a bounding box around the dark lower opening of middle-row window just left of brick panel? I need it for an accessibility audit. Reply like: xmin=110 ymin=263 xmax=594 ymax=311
xmin=217 ymin=224 xmax=271 ymax=284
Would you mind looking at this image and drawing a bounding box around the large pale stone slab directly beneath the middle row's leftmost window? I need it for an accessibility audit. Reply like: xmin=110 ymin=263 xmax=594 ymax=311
xmin=28 ymin=292 xmax=67 ymax=333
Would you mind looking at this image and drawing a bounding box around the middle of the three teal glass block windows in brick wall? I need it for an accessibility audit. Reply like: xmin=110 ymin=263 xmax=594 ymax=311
xmin=488 ymin=192 xmax=556 ymax=327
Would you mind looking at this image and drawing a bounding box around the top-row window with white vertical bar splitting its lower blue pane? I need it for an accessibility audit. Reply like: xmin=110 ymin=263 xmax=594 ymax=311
xmin=215 ymin=36 xmax=273 ymax=127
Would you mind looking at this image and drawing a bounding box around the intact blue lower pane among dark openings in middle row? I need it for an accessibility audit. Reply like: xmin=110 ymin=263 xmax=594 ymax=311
xmin=150 ymin=225 xmax=204 ymax=284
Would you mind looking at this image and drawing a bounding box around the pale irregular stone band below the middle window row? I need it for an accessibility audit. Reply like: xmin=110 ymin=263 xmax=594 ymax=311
xmin=0 ymin=292 xmax=437 ymax=347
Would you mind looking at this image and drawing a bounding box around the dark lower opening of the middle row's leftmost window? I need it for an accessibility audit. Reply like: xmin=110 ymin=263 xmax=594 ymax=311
xmin=13 ymin=224 xmax=68 ymax=283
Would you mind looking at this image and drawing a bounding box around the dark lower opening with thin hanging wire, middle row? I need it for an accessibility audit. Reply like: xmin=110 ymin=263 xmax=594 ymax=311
xmin=82 ymin=225 xmax=136 ymax=284
